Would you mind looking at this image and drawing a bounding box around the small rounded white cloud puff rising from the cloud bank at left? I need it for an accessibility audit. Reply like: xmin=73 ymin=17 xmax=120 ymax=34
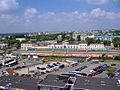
xmin=24 ymin=8 xmax=38 ymax=18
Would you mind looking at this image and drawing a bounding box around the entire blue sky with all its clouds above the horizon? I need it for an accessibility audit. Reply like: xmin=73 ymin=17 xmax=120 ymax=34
xmin=0 ymin=0 xmax=120 ymax=33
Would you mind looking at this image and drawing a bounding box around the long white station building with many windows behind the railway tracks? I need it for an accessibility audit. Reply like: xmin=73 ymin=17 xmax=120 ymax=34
xmin=21 ymin=43 xmax=105 ymax=50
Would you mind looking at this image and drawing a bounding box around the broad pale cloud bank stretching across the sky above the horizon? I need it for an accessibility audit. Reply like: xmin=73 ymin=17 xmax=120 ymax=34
xmin=0 ymin=8 xmax=120 ymax=32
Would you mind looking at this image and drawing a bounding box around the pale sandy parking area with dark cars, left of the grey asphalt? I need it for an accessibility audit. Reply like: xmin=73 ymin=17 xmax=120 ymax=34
xmin=14 ymin=62 xmax=68 ymax=76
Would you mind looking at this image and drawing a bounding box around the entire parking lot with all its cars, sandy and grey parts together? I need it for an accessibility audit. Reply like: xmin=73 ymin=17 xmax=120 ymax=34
xmin=0 ymin=57 xmax=120 ymax=79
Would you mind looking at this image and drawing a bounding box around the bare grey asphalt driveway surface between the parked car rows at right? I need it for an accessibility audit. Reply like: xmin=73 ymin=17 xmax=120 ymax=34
xmin=39 ymin=61 xmax=120 ymax=79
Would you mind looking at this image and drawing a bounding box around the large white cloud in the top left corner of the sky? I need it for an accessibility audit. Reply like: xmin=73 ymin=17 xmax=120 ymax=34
xmin=0 ymin=0 xmax=19 ymax=13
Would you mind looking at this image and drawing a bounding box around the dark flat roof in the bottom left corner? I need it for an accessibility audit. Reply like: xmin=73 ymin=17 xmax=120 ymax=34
xmin=0 ymin=76 xmax=38 ymax=90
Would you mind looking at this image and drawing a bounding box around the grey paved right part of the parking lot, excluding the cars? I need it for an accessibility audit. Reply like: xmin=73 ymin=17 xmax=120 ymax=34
xmin=40 ymin=61 xmax=120 ymax=78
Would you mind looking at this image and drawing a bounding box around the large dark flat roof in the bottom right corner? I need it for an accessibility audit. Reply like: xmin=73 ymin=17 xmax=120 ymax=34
xmin=74 ymin=77 xmax=120 ymax=90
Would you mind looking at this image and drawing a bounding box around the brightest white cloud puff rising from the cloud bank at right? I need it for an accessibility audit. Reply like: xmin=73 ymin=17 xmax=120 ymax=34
xmin=91 ymin=8 xmax=106 ymax=17
